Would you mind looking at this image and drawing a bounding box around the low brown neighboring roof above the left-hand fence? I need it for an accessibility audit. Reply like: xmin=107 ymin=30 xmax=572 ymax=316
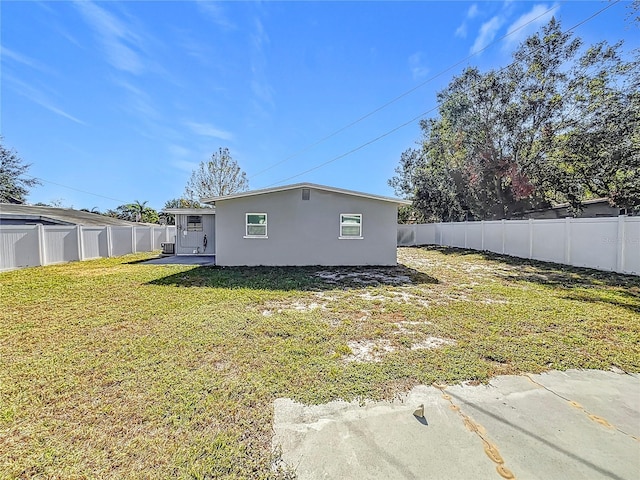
xmin=0 ymin=203 xmax=136 ymax=226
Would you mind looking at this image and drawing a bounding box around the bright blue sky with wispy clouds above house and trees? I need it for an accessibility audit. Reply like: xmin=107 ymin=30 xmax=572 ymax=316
xmin=0 ymin=1 xmax=640 ymax=210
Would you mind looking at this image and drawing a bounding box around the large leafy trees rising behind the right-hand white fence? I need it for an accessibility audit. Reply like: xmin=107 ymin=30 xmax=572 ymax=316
xmin=390 ymin=20 xmax=640 ymax=221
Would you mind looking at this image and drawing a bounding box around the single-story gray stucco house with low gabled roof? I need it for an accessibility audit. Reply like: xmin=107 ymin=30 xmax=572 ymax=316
xmin=165 ymin=183 xmax=410 ymax=266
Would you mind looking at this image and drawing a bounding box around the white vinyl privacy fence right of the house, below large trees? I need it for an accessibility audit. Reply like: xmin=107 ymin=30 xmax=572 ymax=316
xmin=398 ymin=215 xmax=640 ymax=275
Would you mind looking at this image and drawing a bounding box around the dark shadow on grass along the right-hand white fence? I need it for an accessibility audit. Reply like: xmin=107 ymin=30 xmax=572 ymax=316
xmin=421 ymin=246 xmax=640 ymax=313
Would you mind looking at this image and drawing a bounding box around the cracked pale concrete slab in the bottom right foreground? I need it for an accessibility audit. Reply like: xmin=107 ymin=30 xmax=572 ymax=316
xmin=274 ymin=370 xmax=640 ymax=480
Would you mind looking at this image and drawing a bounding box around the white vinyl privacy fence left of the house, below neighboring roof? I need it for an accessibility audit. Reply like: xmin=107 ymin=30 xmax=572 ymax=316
xmin=0 ymin=225 xmax=175 ymax=271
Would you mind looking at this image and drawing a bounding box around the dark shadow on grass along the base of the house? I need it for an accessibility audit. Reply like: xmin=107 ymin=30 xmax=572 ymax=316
xmin=149 ymin=265 xmax=439 ymax=291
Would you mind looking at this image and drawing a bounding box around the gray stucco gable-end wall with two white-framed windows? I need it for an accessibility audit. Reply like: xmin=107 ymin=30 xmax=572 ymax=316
xmin=216 ymin=188 xmax=397 ymax=266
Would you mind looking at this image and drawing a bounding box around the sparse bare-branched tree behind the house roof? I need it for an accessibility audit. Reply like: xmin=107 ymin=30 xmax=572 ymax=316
xmin=185 ymin=148 xmax=249 ymax=201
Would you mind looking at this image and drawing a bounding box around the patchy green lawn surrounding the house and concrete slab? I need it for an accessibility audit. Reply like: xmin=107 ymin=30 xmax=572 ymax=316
xmin=0 ymin=248 xmax=640 ymax=479
